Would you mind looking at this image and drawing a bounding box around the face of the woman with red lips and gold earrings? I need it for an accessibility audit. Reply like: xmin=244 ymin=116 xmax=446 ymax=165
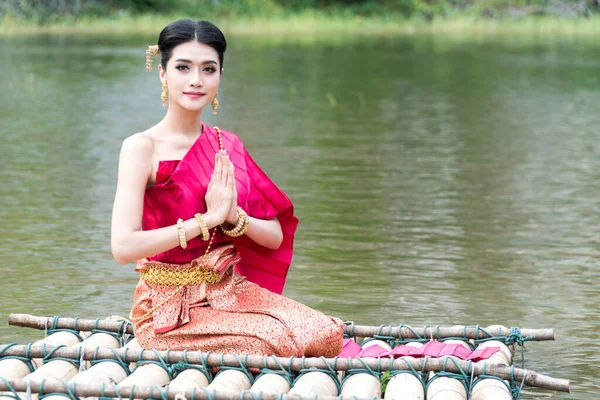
xmin=159 ymin=41 xmax=221 ymax=111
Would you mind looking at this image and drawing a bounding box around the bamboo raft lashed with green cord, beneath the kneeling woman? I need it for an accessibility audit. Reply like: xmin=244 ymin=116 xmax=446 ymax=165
xmin=0 ymin=314 xmax=570 ymax=400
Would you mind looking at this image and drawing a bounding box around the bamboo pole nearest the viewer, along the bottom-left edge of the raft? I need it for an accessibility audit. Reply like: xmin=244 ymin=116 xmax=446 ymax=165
xmin=0 ymin=379 xmax=355 ymax=400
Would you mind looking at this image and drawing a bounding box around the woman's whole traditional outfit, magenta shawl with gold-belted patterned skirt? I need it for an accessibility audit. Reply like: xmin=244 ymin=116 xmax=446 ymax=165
xmin=131 ymin=124 xmax=343 ymax=357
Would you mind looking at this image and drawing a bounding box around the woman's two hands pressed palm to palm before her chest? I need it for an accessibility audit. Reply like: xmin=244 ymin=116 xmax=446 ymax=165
xmin=204 ymin=150 xmax=238 ymax=225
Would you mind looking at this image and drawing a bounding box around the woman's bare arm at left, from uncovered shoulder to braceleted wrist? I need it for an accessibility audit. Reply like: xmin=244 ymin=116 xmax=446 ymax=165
xmin=111 ymin=135 xmax=227 ymax=264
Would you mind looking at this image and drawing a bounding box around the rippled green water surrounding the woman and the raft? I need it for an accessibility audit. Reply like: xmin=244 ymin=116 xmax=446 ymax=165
xmin=0 ymin=34 xmax=600 ymax=399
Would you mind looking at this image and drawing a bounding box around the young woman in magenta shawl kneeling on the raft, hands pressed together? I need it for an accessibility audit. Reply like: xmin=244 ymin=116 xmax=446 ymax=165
xmin=111 ymin=20 xmax=343 ymax=357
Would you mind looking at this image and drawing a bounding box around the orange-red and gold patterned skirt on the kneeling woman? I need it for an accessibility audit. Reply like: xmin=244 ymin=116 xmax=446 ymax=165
xmin=131 ymin=246 xmax=344 ymax=357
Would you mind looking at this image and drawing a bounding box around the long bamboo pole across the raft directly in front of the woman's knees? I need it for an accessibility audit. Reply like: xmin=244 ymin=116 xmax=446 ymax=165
xmin=0 ymin=345 xmax=571 ymax=393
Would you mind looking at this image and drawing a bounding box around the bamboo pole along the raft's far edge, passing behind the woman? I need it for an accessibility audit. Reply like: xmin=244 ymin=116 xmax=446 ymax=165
xmin=8 ymin=314 xmax=554 ymax=341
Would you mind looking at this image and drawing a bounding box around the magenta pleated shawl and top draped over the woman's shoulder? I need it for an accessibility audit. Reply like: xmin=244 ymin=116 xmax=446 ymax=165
xmin=142 ymin=124 xmax=298 ymax=294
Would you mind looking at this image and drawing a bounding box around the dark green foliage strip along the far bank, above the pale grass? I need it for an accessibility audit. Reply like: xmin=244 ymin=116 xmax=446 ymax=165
xmin=0 ymin=0 xmax=600 ymax=25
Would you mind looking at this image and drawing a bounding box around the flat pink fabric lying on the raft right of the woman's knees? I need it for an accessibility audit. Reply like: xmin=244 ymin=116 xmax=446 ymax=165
xmin=338 ymin=339 xmax=500 ymax=361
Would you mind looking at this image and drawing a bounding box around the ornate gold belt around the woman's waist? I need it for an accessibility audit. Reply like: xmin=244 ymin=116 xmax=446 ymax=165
xmin=140 ymin=266 xmax=221 ymax=286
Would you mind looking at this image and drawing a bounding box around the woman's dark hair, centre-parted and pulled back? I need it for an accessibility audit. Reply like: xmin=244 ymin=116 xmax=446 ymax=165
xmin=158 ymin=19 xmax=227 ymax=69
